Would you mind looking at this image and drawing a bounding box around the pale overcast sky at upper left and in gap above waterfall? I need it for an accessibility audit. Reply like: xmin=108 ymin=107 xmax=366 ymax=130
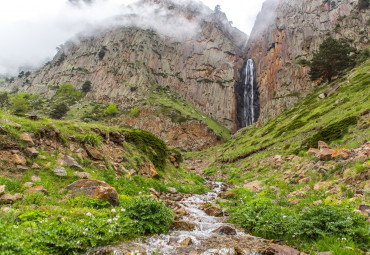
xmin=0 ymin=0 xmax=264 ymax=74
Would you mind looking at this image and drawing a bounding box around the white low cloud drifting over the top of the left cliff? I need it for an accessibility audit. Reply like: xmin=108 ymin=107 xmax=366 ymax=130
xmin=0 ymin=0 xmax=211 ymax=75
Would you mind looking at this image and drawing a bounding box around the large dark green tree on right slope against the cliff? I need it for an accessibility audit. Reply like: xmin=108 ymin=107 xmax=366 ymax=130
xmin=309 ymin=37 xmax=356 ymax=82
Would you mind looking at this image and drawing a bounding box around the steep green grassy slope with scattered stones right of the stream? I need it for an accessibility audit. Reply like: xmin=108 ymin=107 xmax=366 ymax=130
xmin=186 ymin=60 xmax=370 ymax=254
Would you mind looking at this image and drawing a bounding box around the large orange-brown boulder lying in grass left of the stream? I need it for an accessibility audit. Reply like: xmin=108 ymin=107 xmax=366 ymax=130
xmin=66 ymin=179 xmax=119 ymax=206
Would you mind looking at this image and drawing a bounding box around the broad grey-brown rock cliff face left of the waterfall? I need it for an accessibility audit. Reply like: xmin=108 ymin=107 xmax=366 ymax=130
xmin=4 ymin=1 xmax=247 ymax=130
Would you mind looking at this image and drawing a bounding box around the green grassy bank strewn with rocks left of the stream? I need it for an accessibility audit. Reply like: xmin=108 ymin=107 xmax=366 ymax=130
xmin=0 ymin=112 xmax=206 ymax=254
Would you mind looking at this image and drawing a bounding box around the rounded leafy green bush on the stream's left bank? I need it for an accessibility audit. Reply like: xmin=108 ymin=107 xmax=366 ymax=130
xmin=122 ymin=197 xmax=174 ymax=234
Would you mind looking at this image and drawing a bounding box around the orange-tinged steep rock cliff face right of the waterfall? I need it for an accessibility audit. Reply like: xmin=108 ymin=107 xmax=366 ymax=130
xmin=247 ymin=0 xmax=369 ymax=122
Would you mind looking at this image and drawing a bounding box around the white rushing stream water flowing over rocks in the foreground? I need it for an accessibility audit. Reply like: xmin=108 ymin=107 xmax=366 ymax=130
xmin=91 ymin=183 xmax=265 ymax=255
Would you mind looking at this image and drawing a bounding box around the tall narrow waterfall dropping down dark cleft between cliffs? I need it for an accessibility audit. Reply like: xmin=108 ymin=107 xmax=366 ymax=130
xmin=236 ymin=59 xmax=260 ymax=128
